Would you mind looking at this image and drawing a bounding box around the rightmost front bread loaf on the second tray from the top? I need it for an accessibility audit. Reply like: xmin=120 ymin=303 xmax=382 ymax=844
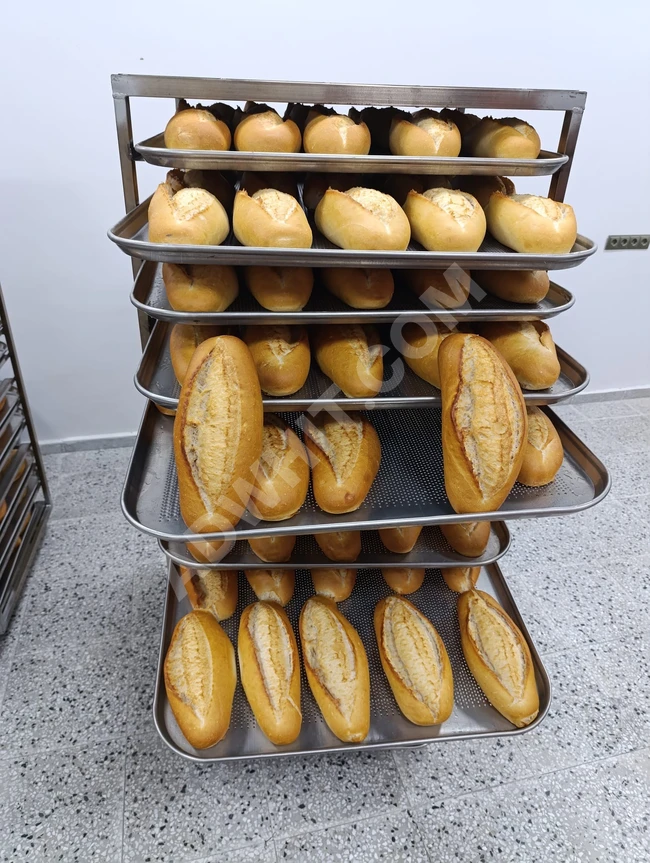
xmin=485 ymin=192 xmax=578 ymax=255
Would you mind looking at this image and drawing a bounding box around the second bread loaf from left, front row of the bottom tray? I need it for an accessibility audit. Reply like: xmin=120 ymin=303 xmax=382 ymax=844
xmin=237 ymin=602 xmax=302 ymax=746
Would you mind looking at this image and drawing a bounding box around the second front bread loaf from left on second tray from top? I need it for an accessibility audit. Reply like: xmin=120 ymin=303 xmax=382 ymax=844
xmin=232 ymin=189 xmax=312 ymax=249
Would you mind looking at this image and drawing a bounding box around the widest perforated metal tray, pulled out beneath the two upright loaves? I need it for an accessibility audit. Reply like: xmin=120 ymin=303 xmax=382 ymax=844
xmin=122 ymin=402 xmax=610 ymax=542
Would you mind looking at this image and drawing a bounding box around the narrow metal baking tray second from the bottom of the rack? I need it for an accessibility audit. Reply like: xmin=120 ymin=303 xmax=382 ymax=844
xmin=158 ymin=521 xmax=510 ymax=569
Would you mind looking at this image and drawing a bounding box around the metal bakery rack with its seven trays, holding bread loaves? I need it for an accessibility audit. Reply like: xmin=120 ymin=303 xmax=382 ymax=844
xmin=109 ymin=75 xmax=610 ymax=761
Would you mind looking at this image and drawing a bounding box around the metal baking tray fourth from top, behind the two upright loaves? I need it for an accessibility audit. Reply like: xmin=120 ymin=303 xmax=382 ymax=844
xmin=134 ymin=321 xmax=589 ymax=411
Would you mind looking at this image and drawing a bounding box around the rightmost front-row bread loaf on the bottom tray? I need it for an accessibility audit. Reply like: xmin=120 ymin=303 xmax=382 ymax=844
xmin=458 ymin=590 xmax=539 ymax=728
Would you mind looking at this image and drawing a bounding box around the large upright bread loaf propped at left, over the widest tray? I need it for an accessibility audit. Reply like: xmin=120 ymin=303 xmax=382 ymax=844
xmin=174 ymin=336 xmax=263 ymax=533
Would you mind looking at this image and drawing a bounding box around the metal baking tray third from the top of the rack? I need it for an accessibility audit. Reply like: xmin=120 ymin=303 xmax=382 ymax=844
xmin=131 ymin=261 xmax=575 ymax=324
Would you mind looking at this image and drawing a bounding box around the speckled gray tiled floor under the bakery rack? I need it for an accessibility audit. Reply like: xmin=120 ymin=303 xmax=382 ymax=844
xmin=0 ymin=399 xmax=650 ymax=863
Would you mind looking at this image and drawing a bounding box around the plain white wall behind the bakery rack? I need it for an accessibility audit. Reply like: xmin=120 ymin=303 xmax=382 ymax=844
xmin=0 ymin=0 xmax=650 ymax=440
